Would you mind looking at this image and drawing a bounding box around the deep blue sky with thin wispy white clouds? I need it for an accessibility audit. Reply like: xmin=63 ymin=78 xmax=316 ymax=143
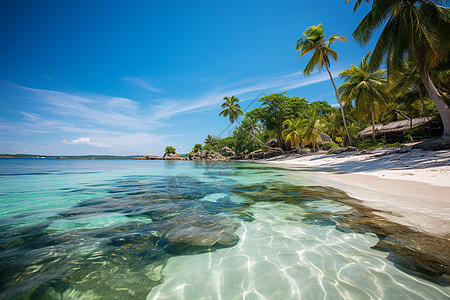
xmin=0 ymin=0 xmax=372 ymax=155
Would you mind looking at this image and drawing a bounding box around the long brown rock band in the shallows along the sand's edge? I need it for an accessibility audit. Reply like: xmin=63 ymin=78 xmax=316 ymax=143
xmin=232 ymin=182 xmax=450 ymax=285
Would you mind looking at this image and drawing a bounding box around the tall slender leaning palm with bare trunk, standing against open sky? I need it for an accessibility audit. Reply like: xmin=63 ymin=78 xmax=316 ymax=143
xmin=295 ymin=24 xmax=352 ymax=145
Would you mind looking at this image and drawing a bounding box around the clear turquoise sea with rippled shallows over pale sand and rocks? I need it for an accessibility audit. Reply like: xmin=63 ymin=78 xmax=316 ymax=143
xmin=0 ymin=159 xmax=450 ymax=300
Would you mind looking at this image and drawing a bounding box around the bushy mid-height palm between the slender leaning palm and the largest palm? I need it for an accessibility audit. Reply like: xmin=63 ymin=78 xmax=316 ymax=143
xmin=339 ymin=51 xmax=387 ymax=141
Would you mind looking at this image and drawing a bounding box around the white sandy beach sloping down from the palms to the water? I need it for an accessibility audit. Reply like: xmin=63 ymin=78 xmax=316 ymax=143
xmin=264 ymin=149 xmax=450 ymax=238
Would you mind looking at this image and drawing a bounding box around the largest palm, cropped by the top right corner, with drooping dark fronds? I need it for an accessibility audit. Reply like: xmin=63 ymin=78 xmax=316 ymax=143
xmin=353 ymin=0 xmax=450 ymax=139
